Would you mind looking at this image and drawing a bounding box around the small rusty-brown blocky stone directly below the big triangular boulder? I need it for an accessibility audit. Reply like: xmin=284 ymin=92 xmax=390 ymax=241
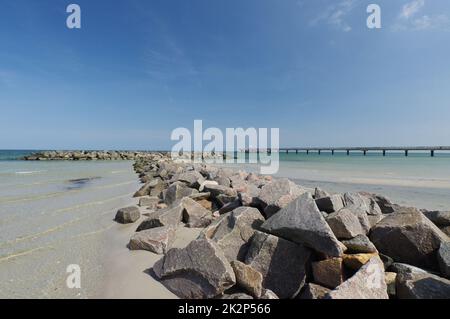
xmin=312 ymin=258 xmax=344 ymax=289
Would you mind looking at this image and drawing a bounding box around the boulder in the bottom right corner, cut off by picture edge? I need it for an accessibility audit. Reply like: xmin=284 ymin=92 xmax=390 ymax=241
xmin=396 ymin=271 xmax=450 ymax=299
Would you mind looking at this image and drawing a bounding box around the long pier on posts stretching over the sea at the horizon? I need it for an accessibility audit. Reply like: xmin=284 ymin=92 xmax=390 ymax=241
xmin=246 ymin=146 xmax=450 ymax=157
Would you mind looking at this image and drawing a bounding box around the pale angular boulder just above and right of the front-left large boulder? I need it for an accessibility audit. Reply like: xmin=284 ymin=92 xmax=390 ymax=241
xmin=199 ymin=207 xmax=264 ymax=262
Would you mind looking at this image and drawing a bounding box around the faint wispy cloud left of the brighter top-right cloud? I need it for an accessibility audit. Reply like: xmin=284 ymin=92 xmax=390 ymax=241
xmin=310 ymin=0 xmax=356 ymax=32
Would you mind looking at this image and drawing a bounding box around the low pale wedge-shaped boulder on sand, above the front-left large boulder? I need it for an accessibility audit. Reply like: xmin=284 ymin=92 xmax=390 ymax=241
xmin=128 ymin=226 xmax=175 ymax=254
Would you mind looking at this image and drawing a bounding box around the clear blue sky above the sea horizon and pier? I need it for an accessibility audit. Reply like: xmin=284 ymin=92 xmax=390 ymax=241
xmin=0 ymin=0 xmax=450 ymax=149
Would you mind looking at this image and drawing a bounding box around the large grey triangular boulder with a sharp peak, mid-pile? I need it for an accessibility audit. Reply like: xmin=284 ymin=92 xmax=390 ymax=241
xmin=262 ymin=193 xmax=343 ymax=257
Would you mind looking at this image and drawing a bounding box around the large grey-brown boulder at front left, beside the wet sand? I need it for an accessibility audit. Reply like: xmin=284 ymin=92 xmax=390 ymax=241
xmin=153 ymin=239 xmax=236 ymax=299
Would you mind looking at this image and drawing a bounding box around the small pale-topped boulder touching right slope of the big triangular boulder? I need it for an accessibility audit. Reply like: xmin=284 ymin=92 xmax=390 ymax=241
xmin=326 ymin=209 xmax=366 ymax=239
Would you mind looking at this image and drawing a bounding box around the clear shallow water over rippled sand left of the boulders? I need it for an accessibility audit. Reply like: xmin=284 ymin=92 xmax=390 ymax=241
xmin=0 ymin=161 xmax=139 ymax=298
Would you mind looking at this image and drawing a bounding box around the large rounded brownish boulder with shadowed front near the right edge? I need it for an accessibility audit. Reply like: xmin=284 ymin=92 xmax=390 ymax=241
xmin=370 ymin=208 xmax=448 ymax=270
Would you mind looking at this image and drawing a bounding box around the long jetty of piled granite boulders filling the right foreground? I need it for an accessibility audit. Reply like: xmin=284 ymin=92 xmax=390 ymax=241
xmin=116 ymin=153 xmax=450 ymax=299
